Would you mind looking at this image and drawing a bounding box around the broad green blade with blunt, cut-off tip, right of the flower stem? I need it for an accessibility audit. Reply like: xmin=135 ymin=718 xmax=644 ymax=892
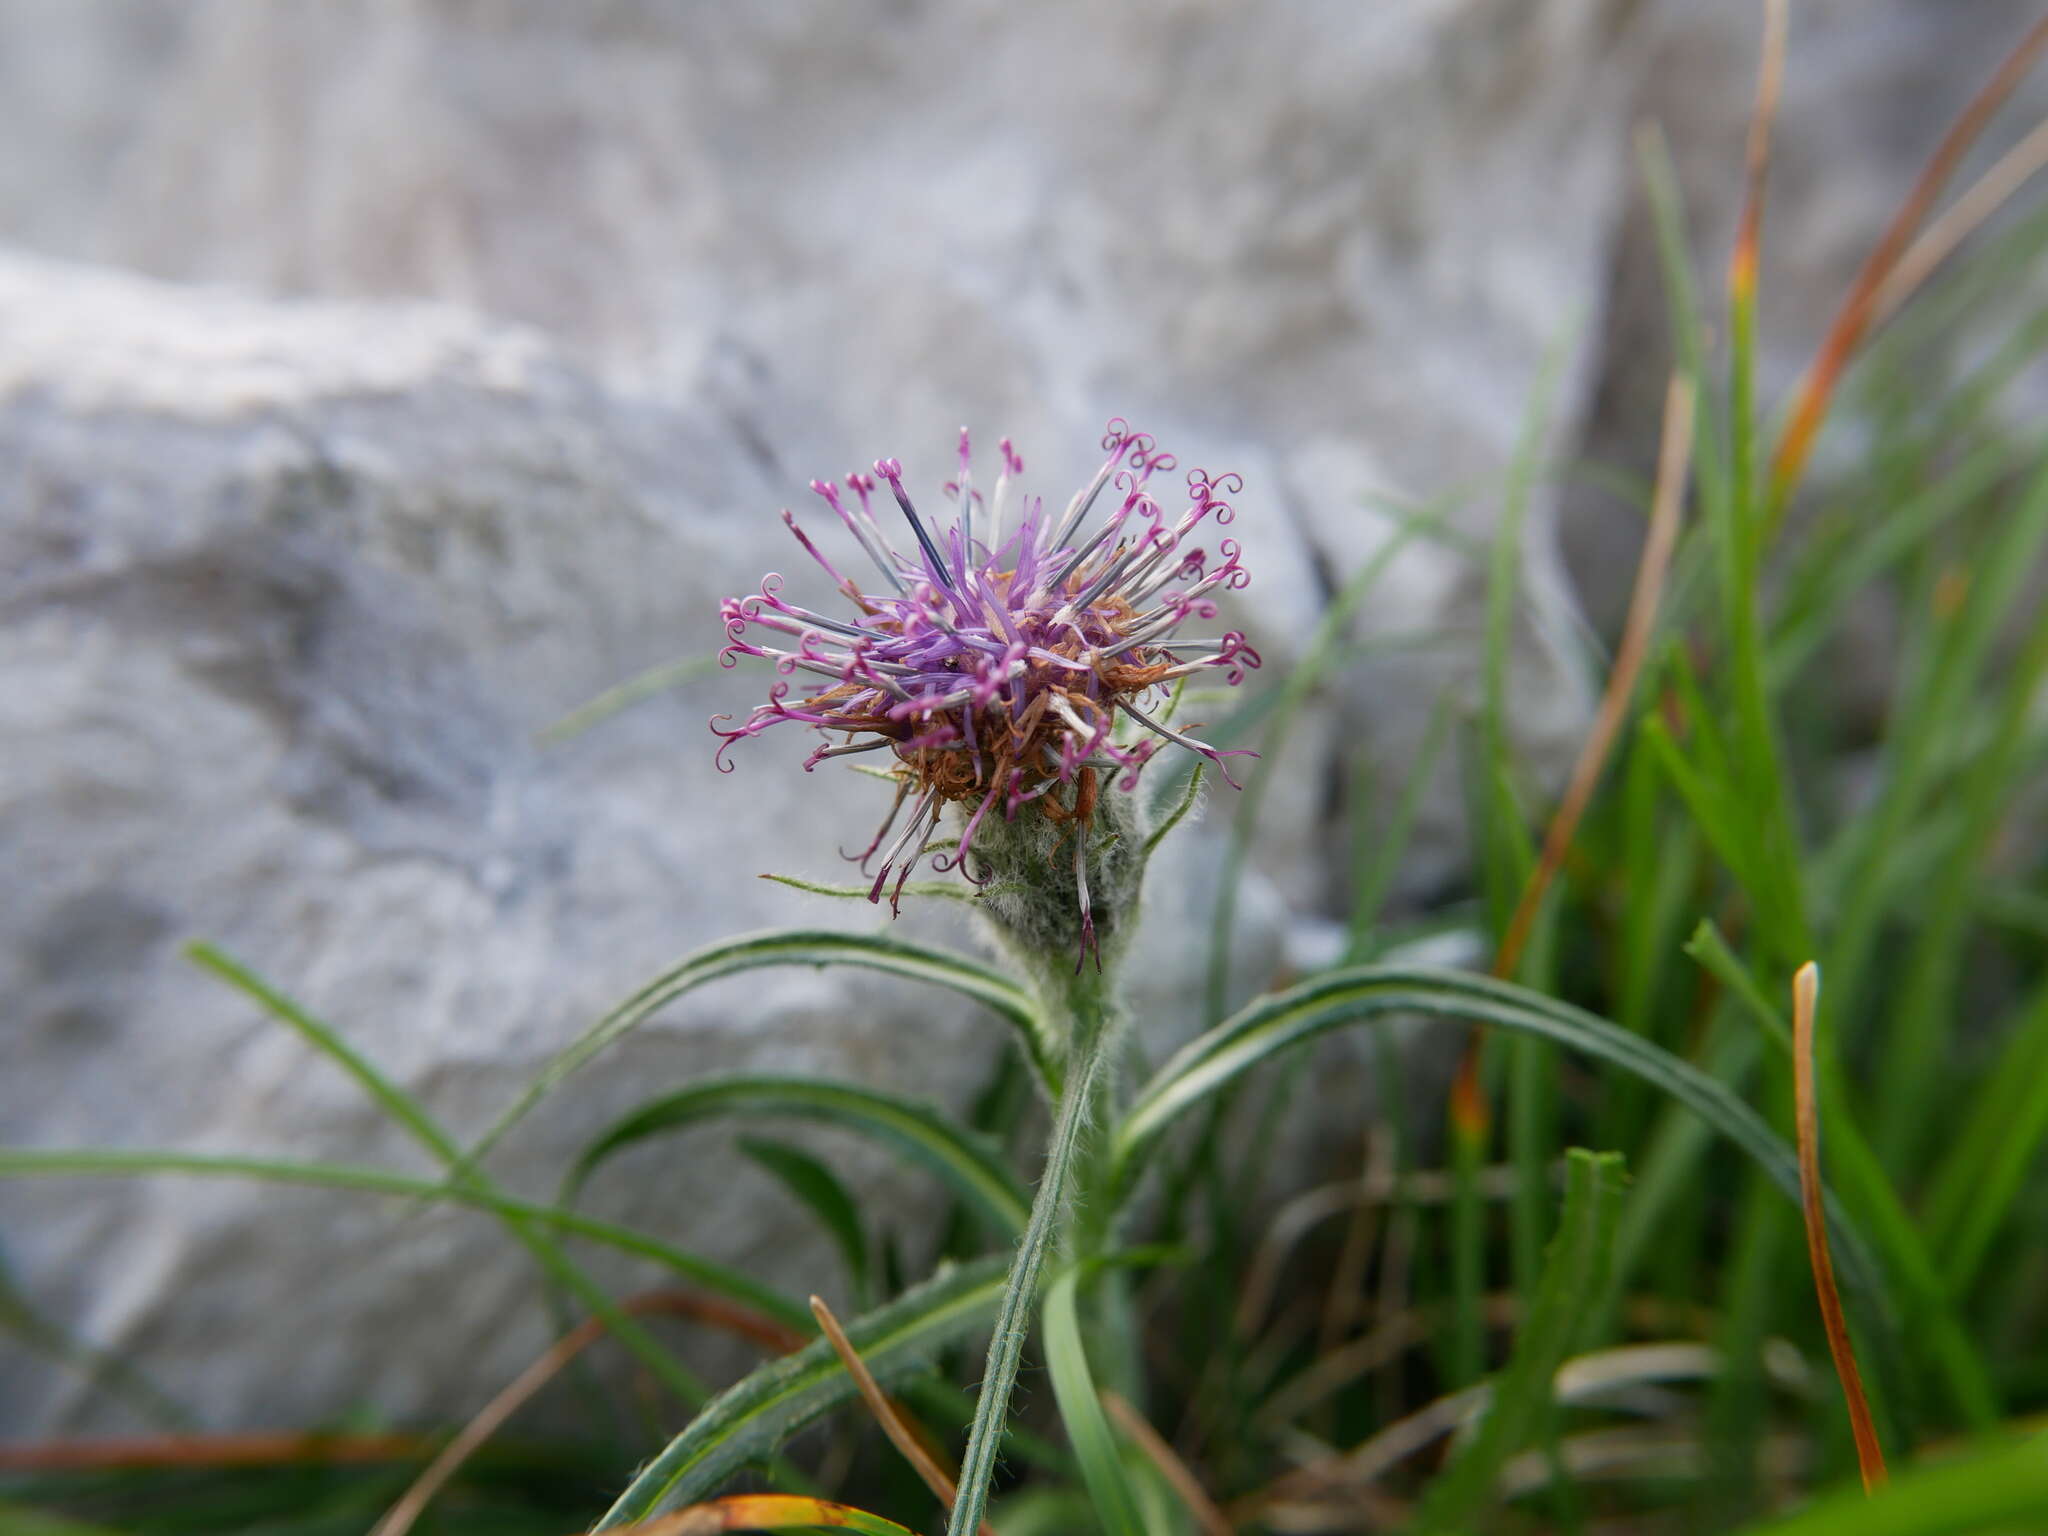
xmin=1415 ymin=1147 xmax=1626 ymax=1532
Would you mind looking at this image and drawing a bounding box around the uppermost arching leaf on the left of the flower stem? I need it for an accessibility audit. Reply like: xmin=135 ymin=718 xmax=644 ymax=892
xmin=465 ymin=928 xmax=1059 ymax=1163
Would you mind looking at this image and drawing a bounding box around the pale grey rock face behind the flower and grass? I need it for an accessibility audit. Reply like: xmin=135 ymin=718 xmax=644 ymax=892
xmin=0 ymin=0 xmax=2044 ymax=1434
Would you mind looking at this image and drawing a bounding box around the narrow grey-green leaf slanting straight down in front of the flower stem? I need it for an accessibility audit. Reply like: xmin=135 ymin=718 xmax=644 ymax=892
xmin=946 ymin=977 xmax=1112 ymax=1536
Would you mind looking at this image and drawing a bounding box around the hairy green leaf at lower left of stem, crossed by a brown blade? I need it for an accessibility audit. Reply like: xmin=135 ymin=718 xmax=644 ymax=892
xmin=596 ymin=1255 xmax=1008 ymax=1530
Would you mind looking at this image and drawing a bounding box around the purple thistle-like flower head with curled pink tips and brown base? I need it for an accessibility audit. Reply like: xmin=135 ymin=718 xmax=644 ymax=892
xmin=711 ymin=420 xmax=1260 ymax=958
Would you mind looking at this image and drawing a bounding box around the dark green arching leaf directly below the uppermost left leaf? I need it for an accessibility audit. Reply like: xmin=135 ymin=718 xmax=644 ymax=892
xmin=561 ymin=1075 xmax=1030 ymax=1237
